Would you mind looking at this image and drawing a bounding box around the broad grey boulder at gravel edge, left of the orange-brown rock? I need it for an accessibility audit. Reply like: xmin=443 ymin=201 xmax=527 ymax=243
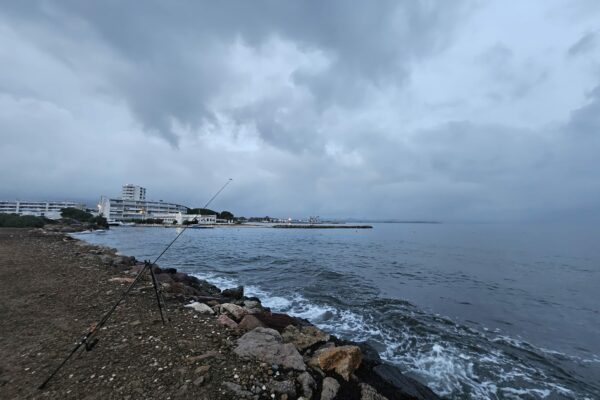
xmin=234 ymin=327 xmax=306 ymax=371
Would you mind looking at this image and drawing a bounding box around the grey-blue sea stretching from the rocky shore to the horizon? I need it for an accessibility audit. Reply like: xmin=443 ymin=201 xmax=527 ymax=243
xmin=77 ymin=224 xmax=600 ymax=399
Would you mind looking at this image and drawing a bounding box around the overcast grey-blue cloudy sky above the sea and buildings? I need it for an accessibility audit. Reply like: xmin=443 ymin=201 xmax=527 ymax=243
xmin=0 ymin=0 xmax=600 ymax=221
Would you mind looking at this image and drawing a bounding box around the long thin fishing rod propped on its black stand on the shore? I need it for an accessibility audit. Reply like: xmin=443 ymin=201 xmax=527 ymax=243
xmin=38 ymin=178 xmax=233 ymax=389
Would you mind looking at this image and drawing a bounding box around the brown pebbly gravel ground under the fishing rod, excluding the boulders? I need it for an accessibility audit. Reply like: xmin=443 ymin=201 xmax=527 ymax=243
xmin=0 ymin=228 xmax=285 ymax=400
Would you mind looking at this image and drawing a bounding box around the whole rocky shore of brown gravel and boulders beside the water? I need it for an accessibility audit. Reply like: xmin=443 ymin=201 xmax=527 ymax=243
xmin=0 ymin=229 xmax=438 ymax=400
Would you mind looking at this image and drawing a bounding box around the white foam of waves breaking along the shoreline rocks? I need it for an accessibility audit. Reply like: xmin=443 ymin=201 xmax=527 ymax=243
xmin=193 ymin=273 xmax=592 ymax=400
